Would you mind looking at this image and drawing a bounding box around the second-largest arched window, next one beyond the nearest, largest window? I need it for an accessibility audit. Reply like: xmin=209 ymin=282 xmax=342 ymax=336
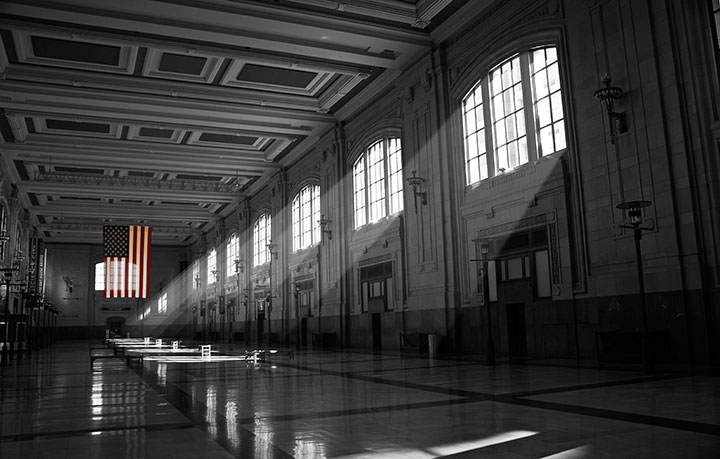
xmin=353 ymin=137 xmax=403 ymax=228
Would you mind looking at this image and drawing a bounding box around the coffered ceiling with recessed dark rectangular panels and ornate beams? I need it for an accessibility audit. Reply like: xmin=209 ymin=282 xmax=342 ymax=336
xmin=0 ymin=0 xmax=467 ymax=245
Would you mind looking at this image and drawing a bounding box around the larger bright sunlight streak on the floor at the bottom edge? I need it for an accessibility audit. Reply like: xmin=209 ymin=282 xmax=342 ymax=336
xmin=336 ymin=430 xmax=536 ymax=459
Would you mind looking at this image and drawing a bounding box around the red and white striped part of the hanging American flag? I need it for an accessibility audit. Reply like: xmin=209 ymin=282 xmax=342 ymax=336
xmin=105 ymin=226 xmax=152 ymax=298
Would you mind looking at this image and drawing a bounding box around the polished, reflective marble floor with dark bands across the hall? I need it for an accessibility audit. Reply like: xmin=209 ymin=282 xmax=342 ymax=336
xmin=0 ymin=342 xmax=720 ymax=459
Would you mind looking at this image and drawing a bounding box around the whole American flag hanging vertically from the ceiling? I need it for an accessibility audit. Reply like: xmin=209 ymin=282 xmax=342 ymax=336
xmin=103 ymin=226 xmax=152 ymax=298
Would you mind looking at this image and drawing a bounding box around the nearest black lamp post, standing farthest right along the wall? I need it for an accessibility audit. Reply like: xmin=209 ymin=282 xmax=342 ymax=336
xmin=617 ymin=201 xmax=654 ymax=374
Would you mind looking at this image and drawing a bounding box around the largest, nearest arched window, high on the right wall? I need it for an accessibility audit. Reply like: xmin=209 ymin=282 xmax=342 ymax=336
xmin=462 ymin=47 xmax=567 ymax=185
